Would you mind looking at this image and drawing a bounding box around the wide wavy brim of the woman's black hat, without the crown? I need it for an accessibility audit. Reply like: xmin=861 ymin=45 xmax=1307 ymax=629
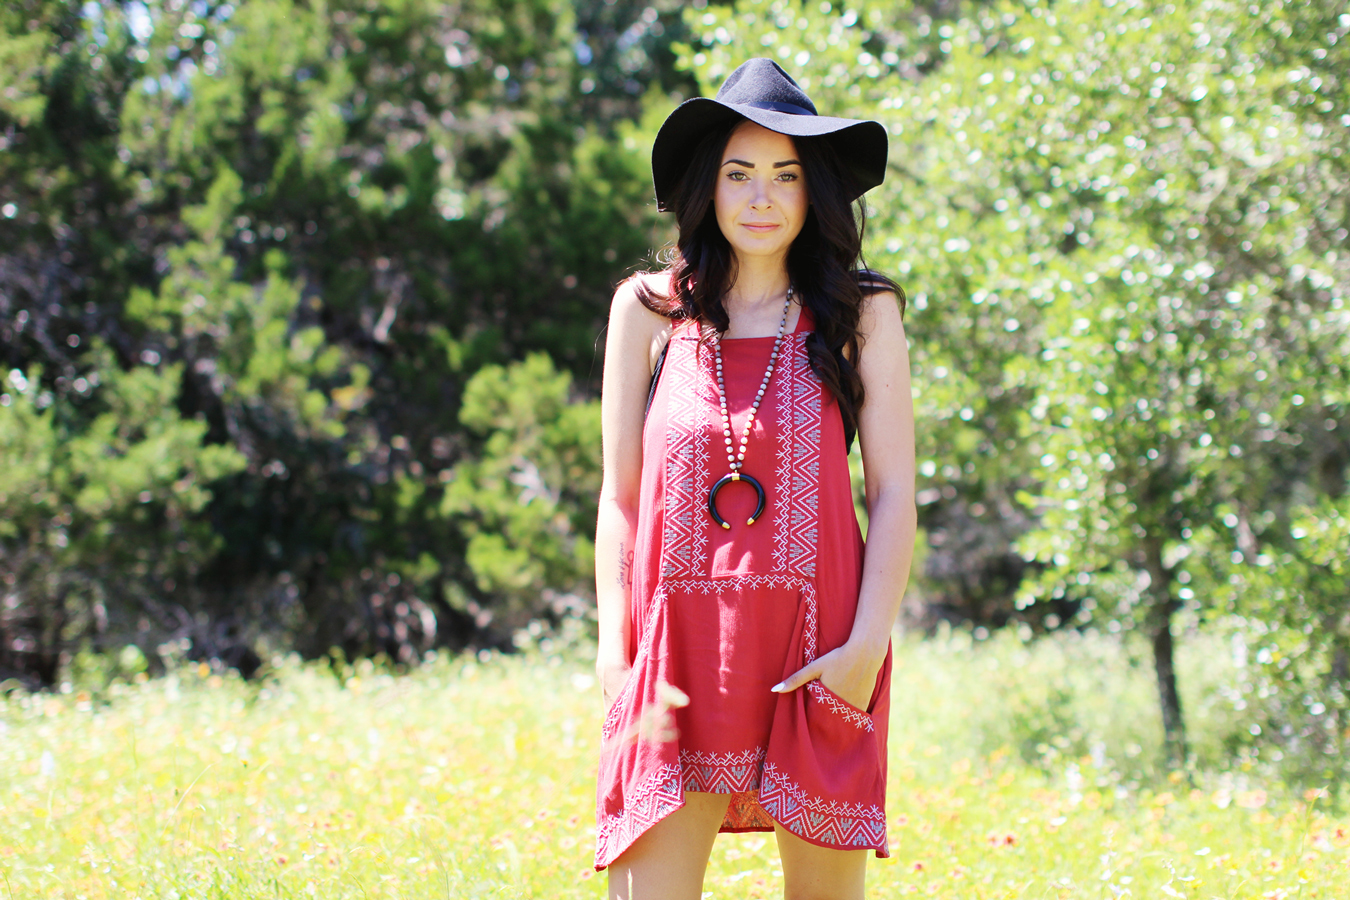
xmin=652 ymin=97 xmax=887 ymax=210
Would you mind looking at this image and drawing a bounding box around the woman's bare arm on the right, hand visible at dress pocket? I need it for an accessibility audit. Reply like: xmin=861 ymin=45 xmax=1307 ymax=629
xmin=778 ymin=293 xmax=917 ymax=707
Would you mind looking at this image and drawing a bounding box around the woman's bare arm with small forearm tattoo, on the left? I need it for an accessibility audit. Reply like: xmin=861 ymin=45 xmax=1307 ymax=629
xmin=595 ymin=275 xmax=670 ymax=708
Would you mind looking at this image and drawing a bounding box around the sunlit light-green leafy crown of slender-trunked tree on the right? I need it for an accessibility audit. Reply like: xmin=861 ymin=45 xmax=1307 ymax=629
xmin=892 ymin=4 xmax=1350 ymax=766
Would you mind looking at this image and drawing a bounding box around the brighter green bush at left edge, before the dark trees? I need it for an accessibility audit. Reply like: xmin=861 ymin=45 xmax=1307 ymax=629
xmin=0 ymin=358 xmax=244 ymax=679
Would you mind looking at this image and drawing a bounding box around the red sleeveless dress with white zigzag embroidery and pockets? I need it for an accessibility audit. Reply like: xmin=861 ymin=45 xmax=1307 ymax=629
xmin=595 ymin=310 xmax=891 ymax=869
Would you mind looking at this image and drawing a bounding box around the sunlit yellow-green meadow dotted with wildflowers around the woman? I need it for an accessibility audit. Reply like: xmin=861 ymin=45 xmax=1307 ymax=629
xmin=0 ymin=637 xmax=1350 ymax=900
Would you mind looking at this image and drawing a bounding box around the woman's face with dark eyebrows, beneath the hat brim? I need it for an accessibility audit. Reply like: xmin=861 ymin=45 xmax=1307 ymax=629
xmin=713 ymin=121 xmax=809 ymax=259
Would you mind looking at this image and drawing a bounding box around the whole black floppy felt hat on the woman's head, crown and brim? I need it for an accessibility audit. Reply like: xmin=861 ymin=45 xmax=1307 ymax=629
xmin=652 ymin=58 xmax=886 ymax=210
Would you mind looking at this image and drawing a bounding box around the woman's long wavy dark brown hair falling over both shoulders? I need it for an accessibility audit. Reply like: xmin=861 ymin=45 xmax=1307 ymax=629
xmin=633 ymin=117 xmax=905 ymax=447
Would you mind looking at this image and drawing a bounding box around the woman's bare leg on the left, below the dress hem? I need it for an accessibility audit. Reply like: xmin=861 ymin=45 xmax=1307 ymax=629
xmin=609 ymin=791 xmax=732 ymax=900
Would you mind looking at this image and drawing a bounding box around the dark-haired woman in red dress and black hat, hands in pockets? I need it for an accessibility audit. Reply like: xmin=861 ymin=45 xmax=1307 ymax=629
xmin=595 ymin=59 xmax=915 ymax=900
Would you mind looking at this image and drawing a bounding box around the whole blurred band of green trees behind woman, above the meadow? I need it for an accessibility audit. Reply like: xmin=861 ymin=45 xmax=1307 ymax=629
xmin=0 ymin=0 xmax=1350 ymax=781
